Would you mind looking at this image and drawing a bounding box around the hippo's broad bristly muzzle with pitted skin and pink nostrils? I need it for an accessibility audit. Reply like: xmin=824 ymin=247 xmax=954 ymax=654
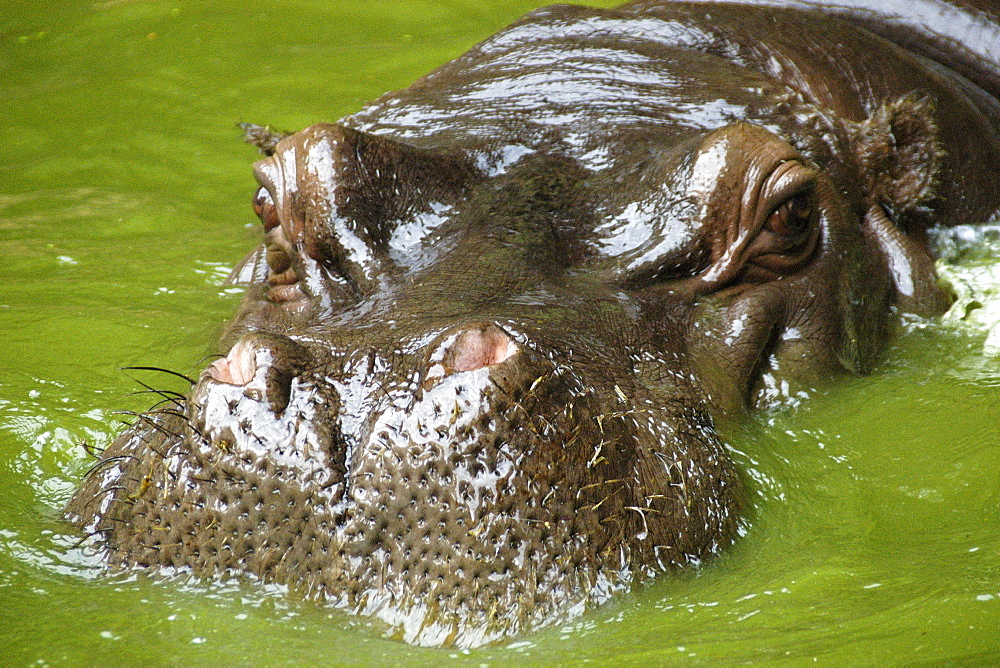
xmin=143 ymin=319 xmax=738 ymax=645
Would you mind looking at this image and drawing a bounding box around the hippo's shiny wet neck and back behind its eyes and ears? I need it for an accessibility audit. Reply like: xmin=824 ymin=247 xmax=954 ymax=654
xmin=341 ymin=0 xmax=1000 ymax=225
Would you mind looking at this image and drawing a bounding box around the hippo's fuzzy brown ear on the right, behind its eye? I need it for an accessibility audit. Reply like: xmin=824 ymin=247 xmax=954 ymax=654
xmin=852 ymin=93 xmax=944 ymax=222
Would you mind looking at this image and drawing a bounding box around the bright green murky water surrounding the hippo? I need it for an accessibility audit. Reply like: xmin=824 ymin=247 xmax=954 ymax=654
xmin=0 ymin=0 xmax=1000 ymax=665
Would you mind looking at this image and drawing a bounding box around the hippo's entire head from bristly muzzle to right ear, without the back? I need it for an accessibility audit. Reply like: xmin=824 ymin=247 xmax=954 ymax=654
xmin=69 ymin=0 xmax=956 ymax=646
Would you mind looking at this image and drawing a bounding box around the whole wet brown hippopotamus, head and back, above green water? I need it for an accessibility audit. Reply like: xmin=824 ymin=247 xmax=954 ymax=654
xmin=67 ymin=0 xmax=1000 ymax=647
